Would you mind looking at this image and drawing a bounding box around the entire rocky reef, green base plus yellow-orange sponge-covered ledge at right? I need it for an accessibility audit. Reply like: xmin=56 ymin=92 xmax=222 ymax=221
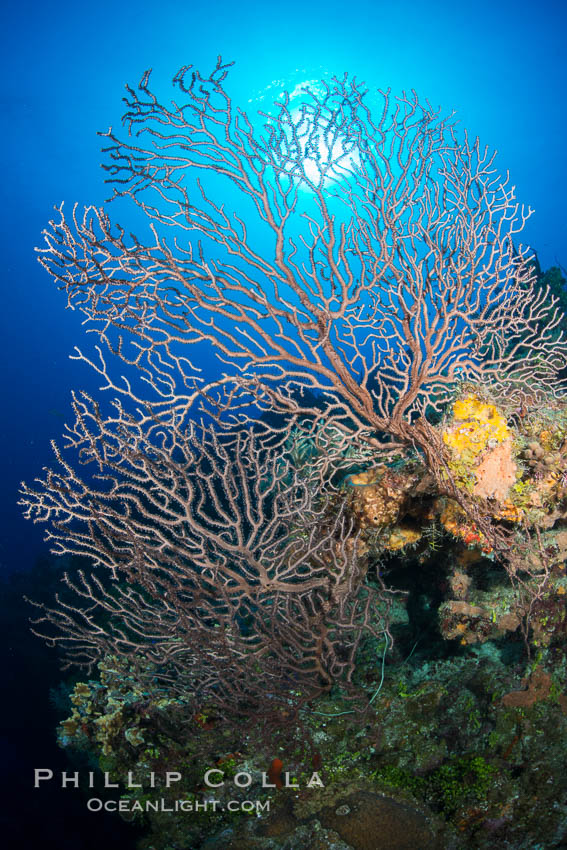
xmin=45 ymin=389 xmax=567 ymax=850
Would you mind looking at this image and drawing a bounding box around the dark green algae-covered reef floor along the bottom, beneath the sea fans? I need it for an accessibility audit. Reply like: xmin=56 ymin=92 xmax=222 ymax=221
xmin=54 ymin=644 xmax=567 ymax=850
